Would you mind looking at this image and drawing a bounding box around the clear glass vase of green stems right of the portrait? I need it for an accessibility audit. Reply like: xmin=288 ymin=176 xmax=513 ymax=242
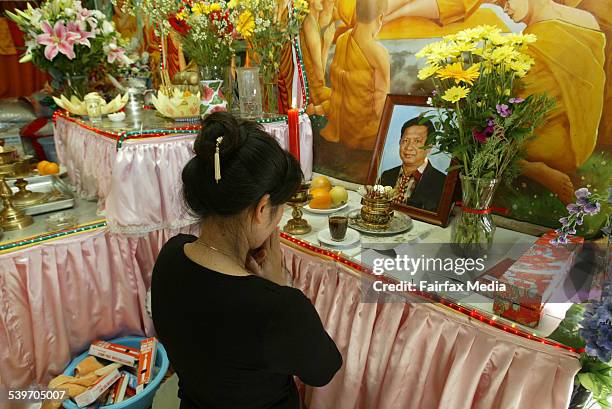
xmin=451 ymin=175 xmax=499 ymax=258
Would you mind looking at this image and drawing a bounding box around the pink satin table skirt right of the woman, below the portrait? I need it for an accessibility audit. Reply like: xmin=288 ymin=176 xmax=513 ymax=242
xmin=284 ymin=246 xmax=580 ymax=409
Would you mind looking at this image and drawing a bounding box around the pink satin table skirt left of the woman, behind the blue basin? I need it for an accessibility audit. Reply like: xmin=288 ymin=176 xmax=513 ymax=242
xmin=0 ymin=226 xmax=198 ymax=388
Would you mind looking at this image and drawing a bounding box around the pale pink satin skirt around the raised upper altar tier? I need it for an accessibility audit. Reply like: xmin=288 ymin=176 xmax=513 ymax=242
xmin=54 ymin=113 xmax=312 ymax=234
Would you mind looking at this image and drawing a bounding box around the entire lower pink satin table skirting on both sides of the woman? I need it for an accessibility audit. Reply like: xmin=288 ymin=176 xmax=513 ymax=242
xmin=0 ymin=226 xmax=580 ymax=409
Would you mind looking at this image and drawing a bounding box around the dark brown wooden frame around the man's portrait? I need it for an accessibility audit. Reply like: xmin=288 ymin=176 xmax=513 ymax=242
xmin=367 ymin=94 xmax=458 ymax=227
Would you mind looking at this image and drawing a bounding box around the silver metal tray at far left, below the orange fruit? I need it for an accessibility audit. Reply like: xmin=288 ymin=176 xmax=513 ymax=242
xmin=7 ymin=175 xmax=74 ymax=216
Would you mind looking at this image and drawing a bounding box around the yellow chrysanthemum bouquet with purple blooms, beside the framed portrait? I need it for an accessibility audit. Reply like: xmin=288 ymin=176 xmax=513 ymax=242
xmin=416 ymin=26 xmax=553 ymax=179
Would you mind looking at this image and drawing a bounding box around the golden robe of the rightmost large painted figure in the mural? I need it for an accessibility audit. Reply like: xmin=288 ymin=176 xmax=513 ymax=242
xmin=522 ymin=20 xmax=606 ymax=173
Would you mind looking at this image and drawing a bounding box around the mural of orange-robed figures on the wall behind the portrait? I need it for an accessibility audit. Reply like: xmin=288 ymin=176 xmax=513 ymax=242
xmin=300 ymin=0 xmax=612 ymax=234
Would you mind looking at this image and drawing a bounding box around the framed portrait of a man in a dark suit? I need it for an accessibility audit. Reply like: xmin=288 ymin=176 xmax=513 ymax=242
xmin=368 ymin=95 xmax=457 ymax=226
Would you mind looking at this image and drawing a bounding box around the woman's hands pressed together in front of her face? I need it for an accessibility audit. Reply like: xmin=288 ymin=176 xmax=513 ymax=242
xmin=246 ymin=228 xmax=287 ymax=285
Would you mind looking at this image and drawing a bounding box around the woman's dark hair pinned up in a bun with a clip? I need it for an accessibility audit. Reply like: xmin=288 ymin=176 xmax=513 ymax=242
xmin=182 ymin=112 xmax=303 ymax=218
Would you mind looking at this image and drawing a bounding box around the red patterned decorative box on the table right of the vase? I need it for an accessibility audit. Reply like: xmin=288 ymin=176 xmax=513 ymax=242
xmin=483 ymin=232 xmax=584 ymax=328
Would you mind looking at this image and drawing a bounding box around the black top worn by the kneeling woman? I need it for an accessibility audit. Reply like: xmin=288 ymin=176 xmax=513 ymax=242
xmin=151 ymin=235 xmax=342 ymax=409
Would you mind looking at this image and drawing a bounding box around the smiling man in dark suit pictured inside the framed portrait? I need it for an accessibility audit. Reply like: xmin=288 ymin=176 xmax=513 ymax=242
xmin=381 ymin=116 xmax=446 ymax=212
